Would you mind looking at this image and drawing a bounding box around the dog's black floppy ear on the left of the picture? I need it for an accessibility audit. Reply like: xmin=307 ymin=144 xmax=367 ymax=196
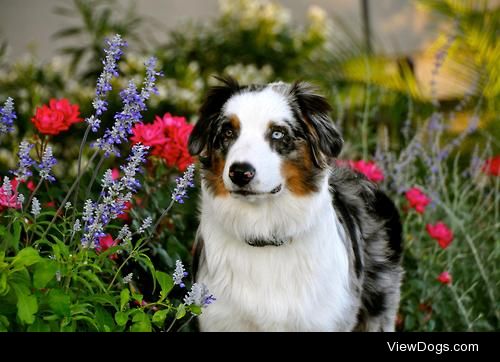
xmin=188 ymin=76 xmax=241 ymax=157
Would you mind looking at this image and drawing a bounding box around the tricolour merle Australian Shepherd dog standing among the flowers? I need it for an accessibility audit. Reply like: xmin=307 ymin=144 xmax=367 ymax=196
xmin=188 ymin=78 xmax=403 ymax=331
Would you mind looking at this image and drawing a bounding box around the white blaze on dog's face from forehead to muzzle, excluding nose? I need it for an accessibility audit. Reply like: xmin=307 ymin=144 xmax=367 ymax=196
xmin=223 ymin=88 xmax=293 ymax=193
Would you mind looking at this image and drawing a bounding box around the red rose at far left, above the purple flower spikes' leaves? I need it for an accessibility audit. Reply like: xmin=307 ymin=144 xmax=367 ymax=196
xmin=31 ymin=98 xmax=83 ymax=135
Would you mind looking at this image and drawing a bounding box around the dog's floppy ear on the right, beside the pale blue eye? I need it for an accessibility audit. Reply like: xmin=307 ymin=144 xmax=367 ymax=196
xmin=290 ymin=82 xmax=344 ymax=166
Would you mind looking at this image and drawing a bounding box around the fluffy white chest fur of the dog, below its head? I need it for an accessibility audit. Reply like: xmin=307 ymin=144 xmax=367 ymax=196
xmin=197 ymin=177 xmax=359 ymax=331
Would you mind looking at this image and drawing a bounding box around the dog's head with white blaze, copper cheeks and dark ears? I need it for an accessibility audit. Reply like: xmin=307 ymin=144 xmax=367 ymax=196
xmin=189 ymin=78 xmax=343 ymax=201
